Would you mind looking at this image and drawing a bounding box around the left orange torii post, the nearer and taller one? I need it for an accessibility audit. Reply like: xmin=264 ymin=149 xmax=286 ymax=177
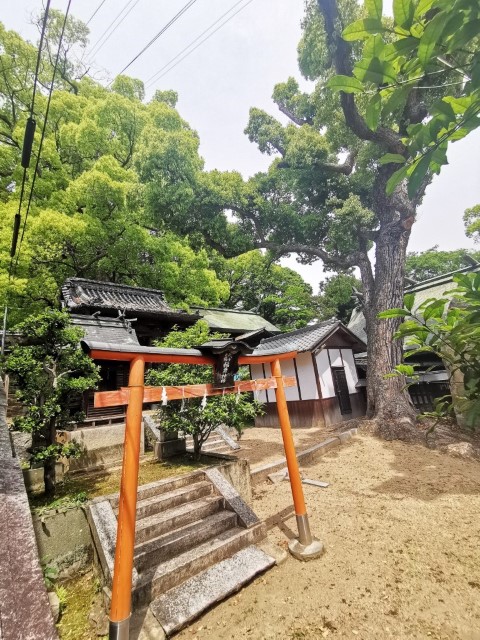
xmin=109 ymin=356 xmax=145 ymax=640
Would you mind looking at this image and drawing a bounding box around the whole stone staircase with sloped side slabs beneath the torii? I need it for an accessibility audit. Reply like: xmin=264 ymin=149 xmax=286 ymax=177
xmin=88 ymin=468 xmax=274 ymax=634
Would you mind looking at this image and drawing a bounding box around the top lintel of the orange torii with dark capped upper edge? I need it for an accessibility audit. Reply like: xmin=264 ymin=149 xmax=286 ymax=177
xmin=81 ymin=340 xmax=297 ymax=366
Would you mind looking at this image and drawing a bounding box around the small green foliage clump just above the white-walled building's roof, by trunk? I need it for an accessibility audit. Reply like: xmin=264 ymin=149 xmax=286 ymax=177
xmin=317 ymin=273 xmax=362 ymax=324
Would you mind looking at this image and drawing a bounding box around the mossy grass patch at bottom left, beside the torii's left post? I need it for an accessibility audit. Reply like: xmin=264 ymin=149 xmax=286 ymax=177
xmin=57 ymin=571 xmax=107 ymax=640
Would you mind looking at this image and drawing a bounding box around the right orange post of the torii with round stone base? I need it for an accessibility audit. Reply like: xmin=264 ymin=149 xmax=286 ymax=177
xmin=272 ymin=360 xmax=324 ymax=560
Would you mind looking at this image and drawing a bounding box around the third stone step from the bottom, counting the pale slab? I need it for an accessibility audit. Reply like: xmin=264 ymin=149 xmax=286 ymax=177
xmin=135 ymin=511 xmax=238 ymax=573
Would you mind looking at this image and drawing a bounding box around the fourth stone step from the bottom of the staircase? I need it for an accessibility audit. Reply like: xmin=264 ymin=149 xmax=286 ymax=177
xmin=135 ymin=495 xmax=224 ymax=544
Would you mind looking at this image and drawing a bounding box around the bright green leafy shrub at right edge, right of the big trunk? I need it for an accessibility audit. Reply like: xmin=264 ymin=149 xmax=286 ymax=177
xmin=380 ymin=273 xmax=480 ymax=428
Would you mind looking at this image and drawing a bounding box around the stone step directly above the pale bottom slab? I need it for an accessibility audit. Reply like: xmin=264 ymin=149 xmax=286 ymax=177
xmin=132 ymin=525 xmax=265 ymax=606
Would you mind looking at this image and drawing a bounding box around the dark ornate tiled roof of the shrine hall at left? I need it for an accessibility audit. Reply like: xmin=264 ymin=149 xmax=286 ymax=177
xmin=62 ymin=278 xmax=194 ymax=320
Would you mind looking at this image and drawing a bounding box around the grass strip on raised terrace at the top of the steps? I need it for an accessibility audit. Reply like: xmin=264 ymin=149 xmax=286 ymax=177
xmin=29 ymin=456 xmax=206 ymax=515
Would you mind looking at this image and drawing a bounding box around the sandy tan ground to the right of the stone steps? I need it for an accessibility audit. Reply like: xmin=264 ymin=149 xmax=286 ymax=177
xmin=176 ymin=430 xmax=480 ymax=640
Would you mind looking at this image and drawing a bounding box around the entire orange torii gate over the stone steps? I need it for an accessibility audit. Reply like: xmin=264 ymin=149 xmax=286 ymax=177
xmin=82 ymin=340 xmax=323 ymax=640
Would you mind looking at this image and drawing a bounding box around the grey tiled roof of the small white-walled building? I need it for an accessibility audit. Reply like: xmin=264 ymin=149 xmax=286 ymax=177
xmin=253 ymin=320 xmax=365 ymax=355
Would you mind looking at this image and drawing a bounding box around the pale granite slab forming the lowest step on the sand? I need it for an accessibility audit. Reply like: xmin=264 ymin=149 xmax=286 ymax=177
xmin=150 ymin=546 xmax=275 ymax=635
